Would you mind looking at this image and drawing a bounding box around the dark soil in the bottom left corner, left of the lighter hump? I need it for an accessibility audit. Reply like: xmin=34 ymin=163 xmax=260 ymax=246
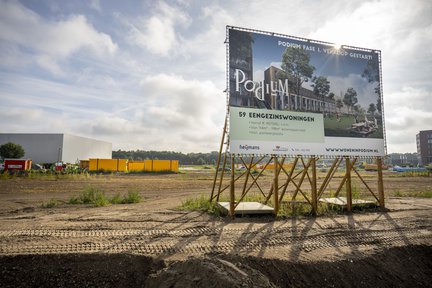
xmin=0 ymin=254 xmax=163 ymax=287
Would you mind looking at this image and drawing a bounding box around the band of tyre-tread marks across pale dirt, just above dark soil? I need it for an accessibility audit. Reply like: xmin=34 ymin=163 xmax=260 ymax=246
xmin=0 ymin=227 xmax=432 ymax=255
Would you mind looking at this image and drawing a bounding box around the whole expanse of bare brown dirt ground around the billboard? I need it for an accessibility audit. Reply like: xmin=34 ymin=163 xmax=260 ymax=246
xmin=0 ymin=171 xmax=432 ymax=287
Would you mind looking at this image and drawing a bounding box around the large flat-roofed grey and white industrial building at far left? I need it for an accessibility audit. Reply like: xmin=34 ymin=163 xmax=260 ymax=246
xmin=0 ymin=133 xmax=112 ymax=163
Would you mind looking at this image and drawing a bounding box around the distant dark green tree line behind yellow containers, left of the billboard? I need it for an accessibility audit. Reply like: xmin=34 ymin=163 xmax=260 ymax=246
xmin=112 ymin=150 xmax=219 ymax=165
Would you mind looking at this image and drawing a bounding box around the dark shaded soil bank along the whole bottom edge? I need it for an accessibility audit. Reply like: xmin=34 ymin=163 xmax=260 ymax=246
xmin=0 ymin=246 xmax=432 ymax=287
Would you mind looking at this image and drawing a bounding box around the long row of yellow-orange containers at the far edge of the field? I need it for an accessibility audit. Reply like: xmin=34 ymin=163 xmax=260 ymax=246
xmin=87 ymin=158 xmax=179 ymax=172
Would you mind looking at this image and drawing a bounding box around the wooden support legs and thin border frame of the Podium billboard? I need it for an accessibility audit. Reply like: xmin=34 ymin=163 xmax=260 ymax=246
xmin=210 ymin=26 xmax=387 ymax=217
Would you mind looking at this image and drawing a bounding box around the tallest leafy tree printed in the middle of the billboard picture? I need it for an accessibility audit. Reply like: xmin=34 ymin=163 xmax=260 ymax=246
xmin=281 ymin=47 xmax=315 ymax=109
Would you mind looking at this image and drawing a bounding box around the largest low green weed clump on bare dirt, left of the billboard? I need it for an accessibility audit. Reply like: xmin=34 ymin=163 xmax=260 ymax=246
xmin=69 ymin=186 xmax=141 ymax=207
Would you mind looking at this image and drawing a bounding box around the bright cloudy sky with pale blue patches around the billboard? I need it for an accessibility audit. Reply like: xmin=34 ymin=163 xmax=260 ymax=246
xmin=0 ymin=0 xmax=432 ymax=153
